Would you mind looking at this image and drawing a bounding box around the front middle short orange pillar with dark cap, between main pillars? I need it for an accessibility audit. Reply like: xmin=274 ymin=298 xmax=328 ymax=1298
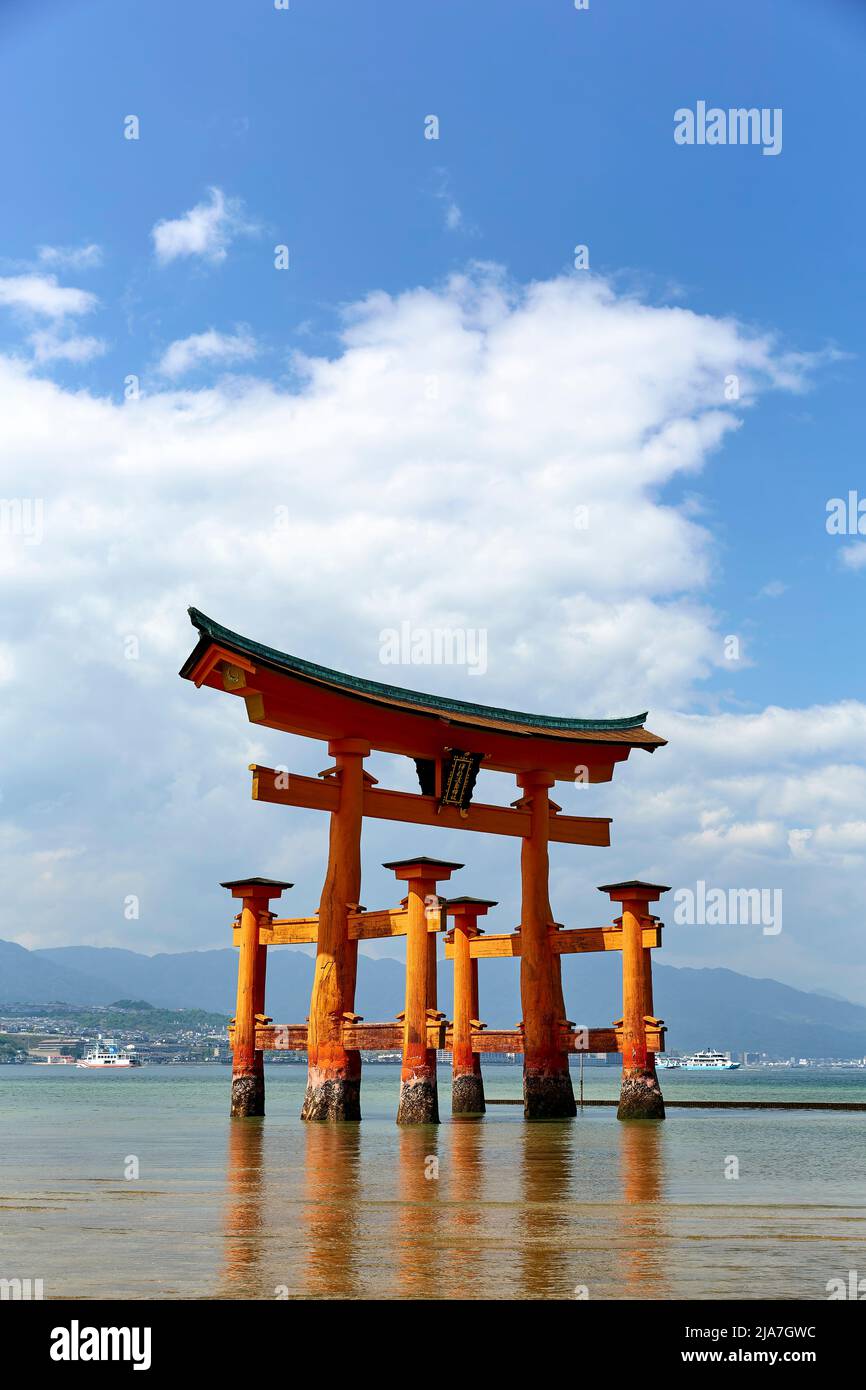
xmin=385 ymin=856 xmax=463 ymax=1125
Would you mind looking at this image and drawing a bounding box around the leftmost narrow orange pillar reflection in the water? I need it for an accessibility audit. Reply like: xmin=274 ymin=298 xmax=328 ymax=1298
xmin=222 ymin=1119 xmax=264 ymax=1298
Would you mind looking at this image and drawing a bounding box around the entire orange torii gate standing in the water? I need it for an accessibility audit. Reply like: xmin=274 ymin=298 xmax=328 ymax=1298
xmin=181 ymin=609 xmax=664 ymax=1123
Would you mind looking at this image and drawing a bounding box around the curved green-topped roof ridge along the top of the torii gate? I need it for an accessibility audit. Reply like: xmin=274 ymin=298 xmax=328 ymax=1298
xmin=181 ymin=607 xmax=648 ymax=733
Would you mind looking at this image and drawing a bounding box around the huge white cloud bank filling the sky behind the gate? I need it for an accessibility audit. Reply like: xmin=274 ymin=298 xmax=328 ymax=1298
xmin=0 ymin=268 xmax=866 ymax=998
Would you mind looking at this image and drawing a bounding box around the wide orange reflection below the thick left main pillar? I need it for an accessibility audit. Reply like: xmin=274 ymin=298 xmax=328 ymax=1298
xmin=300 ymin=1123 xmax=364 ymax=1298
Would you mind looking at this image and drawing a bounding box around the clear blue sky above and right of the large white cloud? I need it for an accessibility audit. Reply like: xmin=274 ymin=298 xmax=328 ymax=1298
xmin=0 ymin=0 xmax=866 ymax=702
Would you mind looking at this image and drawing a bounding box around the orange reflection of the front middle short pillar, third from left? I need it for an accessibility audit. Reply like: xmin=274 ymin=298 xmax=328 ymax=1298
xmin=391 ymin=1125 xmax=448 ymax=1298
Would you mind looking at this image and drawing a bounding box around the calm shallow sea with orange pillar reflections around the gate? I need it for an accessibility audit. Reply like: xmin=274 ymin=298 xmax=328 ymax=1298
xmin=0 ymin=1066 xmax=866 ymax=1300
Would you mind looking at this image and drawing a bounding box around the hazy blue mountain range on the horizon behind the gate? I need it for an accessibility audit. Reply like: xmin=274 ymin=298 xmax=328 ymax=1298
xmin=0 ymin=941 xmax=866 ymax=1058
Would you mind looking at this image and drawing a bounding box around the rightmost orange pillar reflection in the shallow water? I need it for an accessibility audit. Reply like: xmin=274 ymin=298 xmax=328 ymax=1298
xmin=619 ymin=1120 xmax=671 ymax=1298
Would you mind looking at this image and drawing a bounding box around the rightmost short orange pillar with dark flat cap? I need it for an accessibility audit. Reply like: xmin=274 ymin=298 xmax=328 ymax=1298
xmin=601 ymin=880 xmax=669 ymax=1120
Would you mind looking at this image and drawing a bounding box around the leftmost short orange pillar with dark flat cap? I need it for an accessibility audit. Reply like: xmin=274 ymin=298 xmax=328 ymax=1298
xmin=221 ymin=878 xmax=292 ymax=1116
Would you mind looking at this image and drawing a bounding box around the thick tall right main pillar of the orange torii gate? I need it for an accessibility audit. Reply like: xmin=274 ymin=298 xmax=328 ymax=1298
xmin=517 ymin=771 xmax=577 ymax=1119
